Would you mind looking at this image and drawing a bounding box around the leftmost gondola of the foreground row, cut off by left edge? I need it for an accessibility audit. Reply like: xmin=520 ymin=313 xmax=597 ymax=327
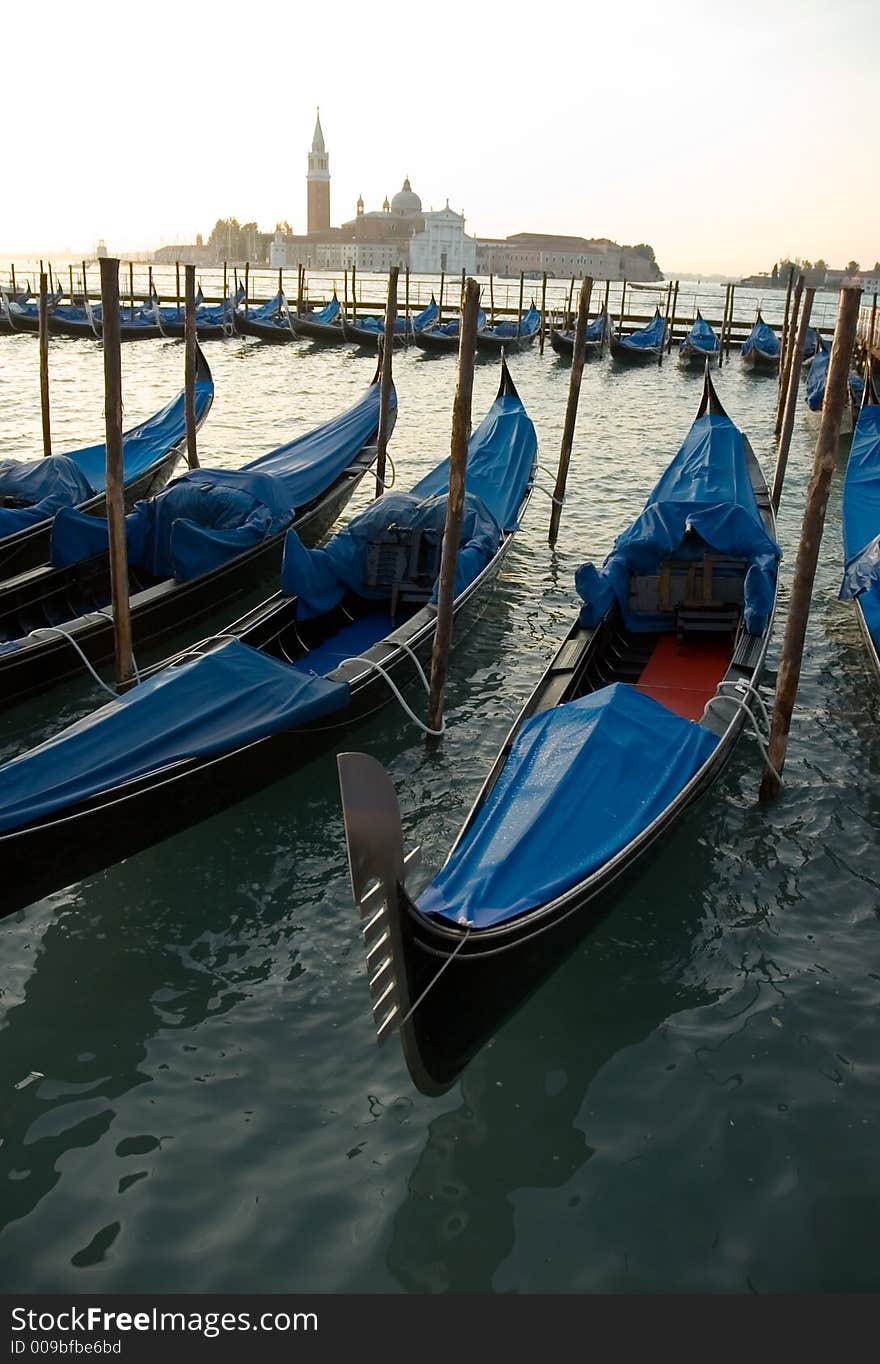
xmin=0 ymin=351 xmax=214 ymax=588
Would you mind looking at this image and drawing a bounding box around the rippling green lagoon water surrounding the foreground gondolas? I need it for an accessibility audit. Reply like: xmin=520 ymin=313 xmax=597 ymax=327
xmin=0 ymin=293 xmax=880 ymax=1292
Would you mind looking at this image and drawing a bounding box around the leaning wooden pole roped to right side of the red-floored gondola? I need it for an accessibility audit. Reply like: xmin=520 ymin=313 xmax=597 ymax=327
xmin=760 ymin=289 xmax=861 ymax=801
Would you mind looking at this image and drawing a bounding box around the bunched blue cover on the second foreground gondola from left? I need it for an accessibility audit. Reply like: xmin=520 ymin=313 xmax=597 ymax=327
xmin=52 ymin=383 xmax=382 ymax=582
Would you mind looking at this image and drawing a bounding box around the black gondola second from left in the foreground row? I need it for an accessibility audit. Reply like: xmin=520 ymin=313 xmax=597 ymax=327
xmin=0 ymin=370 xmax=387 ymax=707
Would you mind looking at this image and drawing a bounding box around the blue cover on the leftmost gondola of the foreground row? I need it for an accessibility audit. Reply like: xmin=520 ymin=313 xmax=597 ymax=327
xmin=0 ymin=379 xmax=214 ymax=537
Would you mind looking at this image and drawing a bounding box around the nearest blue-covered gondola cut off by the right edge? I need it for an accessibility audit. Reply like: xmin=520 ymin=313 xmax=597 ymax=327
xmin=840 ymin=376 xmax=880 ymax=681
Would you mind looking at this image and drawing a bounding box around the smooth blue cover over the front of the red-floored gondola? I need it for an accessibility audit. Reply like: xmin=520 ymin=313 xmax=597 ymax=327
xmin=417 ymin=682 xmax=718 ymax=929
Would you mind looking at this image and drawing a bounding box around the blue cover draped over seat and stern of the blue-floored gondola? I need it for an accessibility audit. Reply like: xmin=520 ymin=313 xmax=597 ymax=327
xmin=281 ymin=396 xmax=538 ymax=619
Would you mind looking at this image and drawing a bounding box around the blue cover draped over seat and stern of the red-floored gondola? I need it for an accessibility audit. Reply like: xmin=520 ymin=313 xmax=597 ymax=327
xmin=574 ymin=412 xmax=782 ymax=634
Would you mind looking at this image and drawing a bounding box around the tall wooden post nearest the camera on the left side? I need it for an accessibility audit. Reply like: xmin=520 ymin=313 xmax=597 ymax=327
xmin=98 ymin=256 xmax=134 ymax=692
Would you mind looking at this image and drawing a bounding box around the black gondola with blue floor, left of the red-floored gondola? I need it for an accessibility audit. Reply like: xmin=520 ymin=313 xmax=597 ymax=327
xmin=0 ymin=370 xmax=538 ymax=915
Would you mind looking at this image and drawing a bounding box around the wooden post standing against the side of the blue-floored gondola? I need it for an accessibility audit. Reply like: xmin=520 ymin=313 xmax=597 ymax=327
xmin=428 ymin=280 xmax=480 ymax=735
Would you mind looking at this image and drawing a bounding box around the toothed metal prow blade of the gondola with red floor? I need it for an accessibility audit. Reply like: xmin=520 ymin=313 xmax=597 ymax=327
xmin=337 ymin=753 xmax=420 ymax=1045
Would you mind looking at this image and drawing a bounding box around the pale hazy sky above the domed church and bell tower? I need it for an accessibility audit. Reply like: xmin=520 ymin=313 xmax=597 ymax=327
xmin=0 ymin=0 xmax=880 ymax=274
